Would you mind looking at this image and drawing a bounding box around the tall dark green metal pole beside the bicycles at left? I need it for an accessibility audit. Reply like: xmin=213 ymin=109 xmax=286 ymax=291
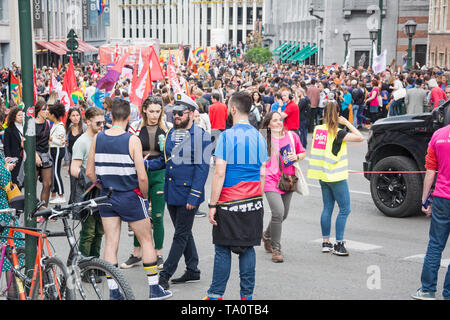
xmin=19 ymin=0 xmax=37 ymax=282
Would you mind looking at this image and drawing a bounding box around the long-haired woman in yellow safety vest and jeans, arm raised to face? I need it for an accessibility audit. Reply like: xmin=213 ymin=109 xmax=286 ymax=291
xmin=308 ymin=102 xmax=364 ymax=256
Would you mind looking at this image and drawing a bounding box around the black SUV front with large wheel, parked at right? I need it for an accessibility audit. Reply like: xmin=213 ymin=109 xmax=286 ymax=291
xmin=363 ymin=101 xmax=450 ymax=218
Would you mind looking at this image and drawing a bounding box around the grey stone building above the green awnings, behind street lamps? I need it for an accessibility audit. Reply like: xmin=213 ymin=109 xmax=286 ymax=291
xmin=264 ymin=0 xmax=429 ymax=67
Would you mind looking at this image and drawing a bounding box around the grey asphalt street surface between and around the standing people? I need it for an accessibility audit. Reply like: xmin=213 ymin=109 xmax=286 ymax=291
xmin=37 ymin=132 xmax=450 ymax=300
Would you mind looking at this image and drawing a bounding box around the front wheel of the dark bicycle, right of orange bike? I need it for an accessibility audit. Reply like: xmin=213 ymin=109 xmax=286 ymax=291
xmin=77 ymin=258 xmax=135 ymax=300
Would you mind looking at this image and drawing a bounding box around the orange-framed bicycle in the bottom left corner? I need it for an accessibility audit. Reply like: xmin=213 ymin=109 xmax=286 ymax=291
xmin=0 ymin=208 xmax=75 ymax=300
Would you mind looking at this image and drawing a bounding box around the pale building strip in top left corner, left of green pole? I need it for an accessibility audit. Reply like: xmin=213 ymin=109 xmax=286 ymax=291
xmin=0 ymin=0 xmax=20 ymax=68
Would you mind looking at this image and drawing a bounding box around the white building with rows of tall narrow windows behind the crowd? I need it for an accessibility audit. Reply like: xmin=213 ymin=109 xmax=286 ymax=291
xmin=110 ymin=0 xmax=264 ymax=47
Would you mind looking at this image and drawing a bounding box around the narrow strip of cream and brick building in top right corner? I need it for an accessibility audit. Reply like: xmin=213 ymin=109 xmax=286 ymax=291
xmin=428 ymin=0 xmax=450 ymax=68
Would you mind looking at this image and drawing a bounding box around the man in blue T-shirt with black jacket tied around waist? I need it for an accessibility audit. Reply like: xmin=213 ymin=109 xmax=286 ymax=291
xmin=205 ymin=92 xmax=269 ymax=300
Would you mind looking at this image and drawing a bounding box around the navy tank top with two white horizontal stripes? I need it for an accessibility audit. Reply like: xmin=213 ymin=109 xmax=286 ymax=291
xmin=95 ymin=131 xmax=139 ymax=191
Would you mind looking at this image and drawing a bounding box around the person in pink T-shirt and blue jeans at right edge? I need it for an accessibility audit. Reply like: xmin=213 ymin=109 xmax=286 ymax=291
xmin=412 ymin=125 xmax=450 ymax=300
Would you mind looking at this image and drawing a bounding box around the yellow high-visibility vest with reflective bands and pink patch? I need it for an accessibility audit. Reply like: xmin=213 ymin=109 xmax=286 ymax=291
xmin=308 ymin=125 xmax=348 ymax=182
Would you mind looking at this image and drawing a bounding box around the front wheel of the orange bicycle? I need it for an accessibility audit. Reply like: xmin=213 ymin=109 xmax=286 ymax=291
xmin=33 ymin=257 xmax=75 ymax=300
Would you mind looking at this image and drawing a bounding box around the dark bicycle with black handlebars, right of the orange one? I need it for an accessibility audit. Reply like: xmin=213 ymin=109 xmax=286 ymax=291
xmin=33 ymin=190 xmax=135 ymax=300
